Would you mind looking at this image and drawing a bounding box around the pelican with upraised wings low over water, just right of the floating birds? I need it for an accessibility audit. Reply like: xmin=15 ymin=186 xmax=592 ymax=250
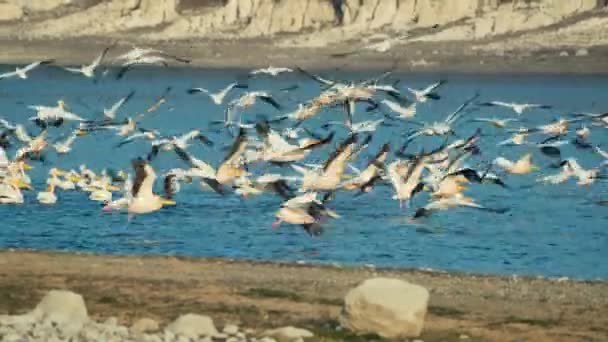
xmin=127 ymin=159 xmax=175 ymax=215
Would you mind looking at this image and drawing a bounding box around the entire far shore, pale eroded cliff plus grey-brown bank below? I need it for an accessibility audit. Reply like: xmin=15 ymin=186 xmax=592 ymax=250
xmin=0 ymin=0 xmax=608 ymax=73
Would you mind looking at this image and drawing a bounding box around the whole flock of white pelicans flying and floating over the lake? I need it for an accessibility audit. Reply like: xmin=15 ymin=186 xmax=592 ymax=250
xmin=0 ymin=48 xmax=608 ymax=235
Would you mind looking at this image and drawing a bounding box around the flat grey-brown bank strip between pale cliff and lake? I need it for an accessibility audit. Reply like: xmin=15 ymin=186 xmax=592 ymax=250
xmin=0 ymin=38 xmax=608 ymax=75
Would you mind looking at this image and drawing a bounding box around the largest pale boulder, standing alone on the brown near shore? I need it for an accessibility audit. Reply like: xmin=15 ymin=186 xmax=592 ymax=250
xmin=340 ymin=278 xmax=429 ymax=338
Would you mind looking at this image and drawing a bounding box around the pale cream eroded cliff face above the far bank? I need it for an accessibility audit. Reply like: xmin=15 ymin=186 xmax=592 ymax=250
xmin=0 ymin=0 xmax=608 ymax=51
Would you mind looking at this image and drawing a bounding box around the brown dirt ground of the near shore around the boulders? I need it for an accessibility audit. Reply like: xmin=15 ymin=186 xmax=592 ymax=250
xmin=0 ymin=251 xmax=608 ymax=341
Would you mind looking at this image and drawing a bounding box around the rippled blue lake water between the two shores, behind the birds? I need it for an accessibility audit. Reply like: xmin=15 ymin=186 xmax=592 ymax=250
xmin=0 ymin=66 xmax=608 ymax=279
